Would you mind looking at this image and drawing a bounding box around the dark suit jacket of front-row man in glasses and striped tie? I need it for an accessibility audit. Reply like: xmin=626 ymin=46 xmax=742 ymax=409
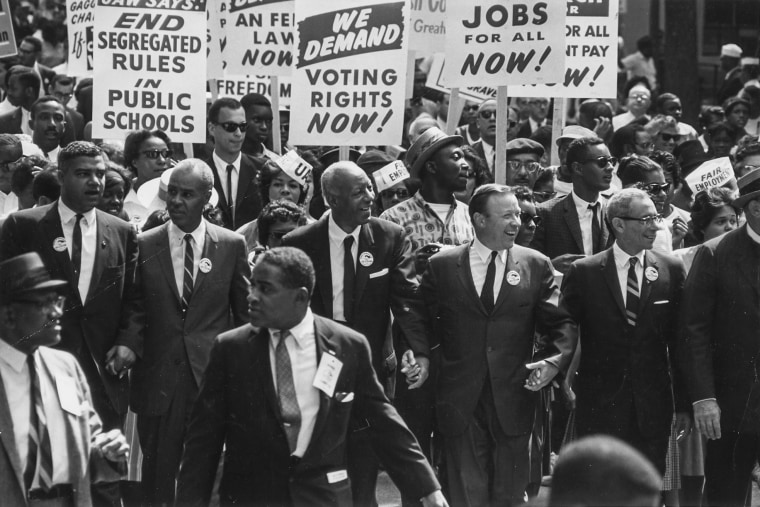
xmin=562 ymin=248 xmax=689 ymax=438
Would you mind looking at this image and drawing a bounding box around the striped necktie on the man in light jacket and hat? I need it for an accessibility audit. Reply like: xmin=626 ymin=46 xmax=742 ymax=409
xmin=24 ymin=354 xmax=53 ymax=491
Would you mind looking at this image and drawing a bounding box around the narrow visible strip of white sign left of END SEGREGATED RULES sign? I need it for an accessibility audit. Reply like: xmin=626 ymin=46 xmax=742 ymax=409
xmin=66 ymin=0 xmax=95 ymax=77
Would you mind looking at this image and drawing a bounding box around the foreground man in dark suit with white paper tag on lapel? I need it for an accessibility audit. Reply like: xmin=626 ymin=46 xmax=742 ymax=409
xmin=177 ymin=247 xmax=447 ymax=507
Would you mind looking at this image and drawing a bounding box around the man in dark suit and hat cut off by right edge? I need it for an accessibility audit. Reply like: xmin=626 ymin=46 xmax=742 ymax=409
xmin=677 ymin=169 xmax=760 ymax=506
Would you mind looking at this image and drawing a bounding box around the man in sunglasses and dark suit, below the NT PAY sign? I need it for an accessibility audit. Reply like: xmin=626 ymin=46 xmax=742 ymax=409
xmin=530 ymin=137 xmax=615 ymax=273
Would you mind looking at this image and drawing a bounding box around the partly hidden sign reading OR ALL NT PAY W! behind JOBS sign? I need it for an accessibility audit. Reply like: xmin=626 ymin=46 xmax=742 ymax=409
xmin=509 ymin=0 xmax=619 ymax=99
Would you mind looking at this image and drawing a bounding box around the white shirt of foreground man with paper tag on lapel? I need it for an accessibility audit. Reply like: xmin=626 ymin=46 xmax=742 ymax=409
xmin=269 ymin=309 xmax=319 ymax=457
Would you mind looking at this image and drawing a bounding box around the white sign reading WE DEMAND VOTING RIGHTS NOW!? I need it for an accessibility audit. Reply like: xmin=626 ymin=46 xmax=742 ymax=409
xmin=290 ymin=0 xmax=409 ymax=146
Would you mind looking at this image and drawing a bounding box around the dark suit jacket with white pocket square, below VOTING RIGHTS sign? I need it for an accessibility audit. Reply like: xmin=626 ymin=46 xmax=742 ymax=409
xmin=282 ymin=216 xmax=430 ymax=381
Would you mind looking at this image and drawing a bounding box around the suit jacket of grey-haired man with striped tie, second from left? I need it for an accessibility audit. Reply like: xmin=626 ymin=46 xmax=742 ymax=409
xmin=130 ymin=223 xmax=250 ymax=416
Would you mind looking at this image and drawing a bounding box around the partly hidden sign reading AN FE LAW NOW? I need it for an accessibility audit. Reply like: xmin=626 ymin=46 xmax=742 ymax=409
xmin=222 ymin=0 xmax=293 ymax=76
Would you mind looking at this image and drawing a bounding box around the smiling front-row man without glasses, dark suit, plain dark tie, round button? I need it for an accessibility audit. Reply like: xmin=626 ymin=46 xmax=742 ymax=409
xmin=421 ymin=184 xmax=577 ymax=506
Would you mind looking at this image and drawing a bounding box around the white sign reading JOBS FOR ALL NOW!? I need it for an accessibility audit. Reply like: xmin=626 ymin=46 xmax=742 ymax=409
xmin=443 ymin=0 xmax=565 ymax=89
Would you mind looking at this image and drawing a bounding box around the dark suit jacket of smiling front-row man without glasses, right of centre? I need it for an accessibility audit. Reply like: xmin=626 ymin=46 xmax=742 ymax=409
xmin=421 ymin=245 xmax=577 ymax=436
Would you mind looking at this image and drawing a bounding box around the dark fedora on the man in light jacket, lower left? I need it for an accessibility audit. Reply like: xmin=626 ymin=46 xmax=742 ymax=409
xmin=0 ymin=254 xmax=67 ymax=303
